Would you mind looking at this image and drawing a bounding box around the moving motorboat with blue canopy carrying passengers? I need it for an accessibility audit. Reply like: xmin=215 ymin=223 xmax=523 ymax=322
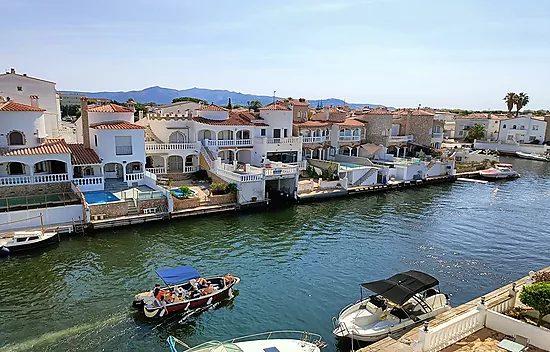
xmin=132 ymin=265 xmax=240 ymax=320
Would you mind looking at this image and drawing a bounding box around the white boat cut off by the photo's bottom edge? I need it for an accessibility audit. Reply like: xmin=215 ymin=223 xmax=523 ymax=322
xmin=167 ymin=330 xmax=327 ymax=352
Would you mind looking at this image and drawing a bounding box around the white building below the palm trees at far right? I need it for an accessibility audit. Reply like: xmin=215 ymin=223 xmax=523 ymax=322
xmin=498 ymin=114 xmax=547 ymax=144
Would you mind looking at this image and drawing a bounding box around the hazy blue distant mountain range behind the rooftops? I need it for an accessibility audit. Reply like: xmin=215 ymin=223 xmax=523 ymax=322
xmin=59 ymin=86 xmax=379 ymax=108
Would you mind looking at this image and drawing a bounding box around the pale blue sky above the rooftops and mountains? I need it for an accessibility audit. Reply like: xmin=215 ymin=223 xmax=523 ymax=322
xmin=0 ymin=0 xmax=550 ymax=109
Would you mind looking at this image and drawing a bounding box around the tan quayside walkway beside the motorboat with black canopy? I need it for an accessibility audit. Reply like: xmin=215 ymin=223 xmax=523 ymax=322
xmin=358 ymin=267 xmax=550 ymax=352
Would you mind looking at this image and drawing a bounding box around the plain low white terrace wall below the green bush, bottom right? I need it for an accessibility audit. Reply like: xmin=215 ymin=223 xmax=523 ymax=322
xmin=485 ymin=310 xmax=550 ymax=351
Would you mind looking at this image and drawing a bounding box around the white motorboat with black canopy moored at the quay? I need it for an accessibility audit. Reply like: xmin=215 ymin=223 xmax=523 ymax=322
xmin=333 ymin=270 xmax=451 ymax=342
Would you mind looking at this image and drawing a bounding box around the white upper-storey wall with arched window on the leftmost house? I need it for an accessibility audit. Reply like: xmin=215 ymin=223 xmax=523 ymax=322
xmin=0 ymin=111 xmax=46 ymax=148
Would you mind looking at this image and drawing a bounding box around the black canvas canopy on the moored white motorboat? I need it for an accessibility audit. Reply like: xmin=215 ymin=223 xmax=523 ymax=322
xmin=361 ymin=270 xmax=439 ymax=305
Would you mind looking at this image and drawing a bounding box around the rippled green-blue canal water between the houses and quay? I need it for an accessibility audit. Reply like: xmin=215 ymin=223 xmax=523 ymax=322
xmin=0 ymin=159 xmax=550 ymax=351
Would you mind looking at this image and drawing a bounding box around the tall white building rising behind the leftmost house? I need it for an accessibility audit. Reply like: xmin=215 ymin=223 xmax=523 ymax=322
xmin=0 ymin=68 xmax=61 ymax=137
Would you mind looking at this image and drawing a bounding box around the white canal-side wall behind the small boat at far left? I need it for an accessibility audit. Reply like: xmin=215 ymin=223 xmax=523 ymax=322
xmin=0 ymin=204 xmax=83 ymax=231
